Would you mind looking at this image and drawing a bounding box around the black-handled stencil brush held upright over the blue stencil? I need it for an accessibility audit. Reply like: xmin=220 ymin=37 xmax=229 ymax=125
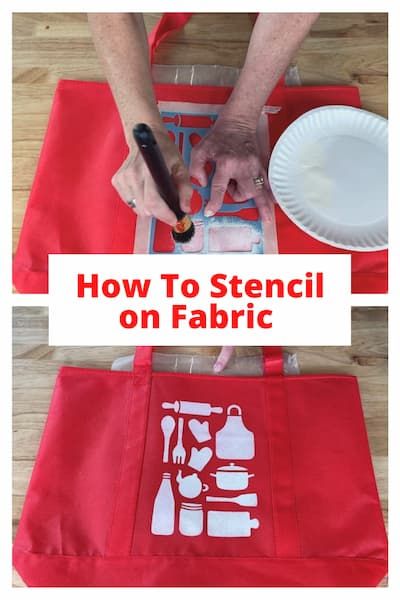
xmin=133 ymin=123 xmax=194 ymax=244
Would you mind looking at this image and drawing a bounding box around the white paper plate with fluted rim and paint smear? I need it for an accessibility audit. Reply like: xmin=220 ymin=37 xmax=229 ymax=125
xmin=269 ymin=106 xmax=388 ymax=251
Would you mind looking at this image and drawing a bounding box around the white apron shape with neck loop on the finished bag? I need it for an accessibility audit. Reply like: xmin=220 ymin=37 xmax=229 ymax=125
xmin=215 ymin=404 xmax=255 ymax=460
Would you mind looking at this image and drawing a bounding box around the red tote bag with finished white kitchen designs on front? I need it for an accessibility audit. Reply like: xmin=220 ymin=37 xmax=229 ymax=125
xmin=14 ymin=347 xmax=387 ymax=587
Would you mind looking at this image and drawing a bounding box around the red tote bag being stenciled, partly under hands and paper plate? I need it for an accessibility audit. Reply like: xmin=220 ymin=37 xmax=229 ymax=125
xmin=13 ymin=13 xmax=387 ymax=293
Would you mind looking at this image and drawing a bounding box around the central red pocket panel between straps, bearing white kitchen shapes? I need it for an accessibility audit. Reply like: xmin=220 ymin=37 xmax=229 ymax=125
xmin=132 ymin=373 xmax=274 ymax=556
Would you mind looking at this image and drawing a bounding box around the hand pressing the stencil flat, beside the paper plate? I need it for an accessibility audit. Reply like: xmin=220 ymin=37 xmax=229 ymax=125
xmin=190 ymin=116 xmax=272 ymax=220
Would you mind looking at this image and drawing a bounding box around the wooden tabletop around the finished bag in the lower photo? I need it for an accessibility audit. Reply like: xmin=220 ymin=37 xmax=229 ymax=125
xmin=13 ymin=307 xmax=388 ymax=586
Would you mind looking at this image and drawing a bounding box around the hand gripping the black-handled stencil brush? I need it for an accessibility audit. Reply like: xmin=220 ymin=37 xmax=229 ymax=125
xmin=111 ymin=128 xmax=193 ymax=227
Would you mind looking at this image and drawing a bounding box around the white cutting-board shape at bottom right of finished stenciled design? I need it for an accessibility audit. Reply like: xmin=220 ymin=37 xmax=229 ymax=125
xmin=207 ymin=510 xmax=260 ymax=537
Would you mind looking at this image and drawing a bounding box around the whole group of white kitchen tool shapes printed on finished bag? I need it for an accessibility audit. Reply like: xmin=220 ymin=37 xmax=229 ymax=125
xmin=151 ymin=400 xmax=260 ymax=538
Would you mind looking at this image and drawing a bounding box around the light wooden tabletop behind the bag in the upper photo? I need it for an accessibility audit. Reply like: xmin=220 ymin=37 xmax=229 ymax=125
xmin=13 ymin=13 xmax=387 ymax=249
